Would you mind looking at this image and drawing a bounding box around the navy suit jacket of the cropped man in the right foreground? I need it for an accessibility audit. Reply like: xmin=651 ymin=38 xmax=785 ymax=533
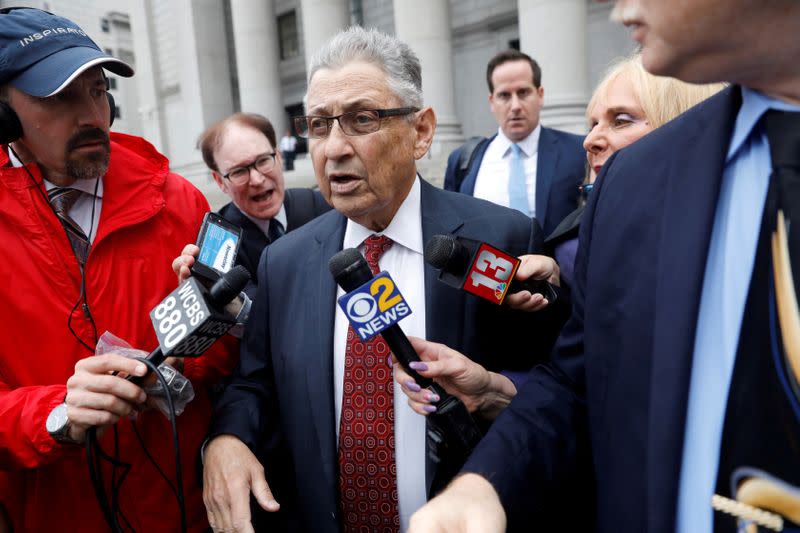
xmin=466 ymin=88 xmax=740 ymax=533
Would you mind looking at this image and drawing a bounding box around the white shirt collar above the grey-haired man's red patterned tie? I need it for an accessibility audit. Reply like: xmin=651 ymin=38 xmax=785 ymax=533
xmin=344 ymin=176 xmax=423 ymax=254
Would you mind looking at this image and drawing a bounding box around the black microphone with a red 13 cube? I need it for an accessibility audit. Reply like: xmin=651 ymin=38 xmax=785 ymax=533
xmin=425 ymin=234 xmax=558 ymax=304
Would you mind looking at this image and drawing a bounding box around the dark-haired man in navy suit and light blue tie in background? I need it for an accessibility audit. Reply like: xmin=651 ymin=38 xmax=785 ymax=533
xmin=444 ymin=50 xmax=586 ymax=235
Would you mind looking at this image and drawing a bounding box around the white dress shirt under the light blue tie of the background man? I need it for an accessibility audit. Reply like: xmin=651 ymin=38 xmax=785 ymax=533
xmin=472 ymin=125 xmax=542 ymax=217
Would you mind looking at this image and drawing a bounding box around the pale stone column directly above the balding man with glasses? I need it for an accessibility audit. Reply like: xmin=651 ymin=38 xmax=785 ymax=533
xmin=231 ymin=0 xmax=287 ymax=138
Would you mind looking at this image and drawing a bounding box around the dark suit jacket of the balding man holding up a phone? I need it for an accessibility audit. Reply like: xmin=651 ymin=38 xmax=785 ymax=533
xmin=219 ymin=189 xmax=331 ymax=281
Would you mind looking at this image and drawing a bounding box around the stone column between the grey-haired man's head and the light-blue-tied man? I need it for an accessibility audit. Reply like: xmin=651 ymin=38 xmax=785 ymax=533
xmin=393 ymin=0 xmax=464 ymax=158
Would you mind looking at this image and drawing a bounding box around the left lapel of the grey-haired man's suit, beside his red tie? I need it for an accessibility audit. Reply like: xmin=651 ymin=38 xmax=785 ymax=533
xmin=298 ymin=213 xmax=347 ymax=486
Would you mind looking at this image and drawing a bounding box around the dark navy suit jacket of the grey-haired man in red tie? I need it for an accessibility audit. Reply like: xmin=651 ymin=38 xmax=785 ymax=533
xmin=212 ymin=181 xmax=559 ymax=533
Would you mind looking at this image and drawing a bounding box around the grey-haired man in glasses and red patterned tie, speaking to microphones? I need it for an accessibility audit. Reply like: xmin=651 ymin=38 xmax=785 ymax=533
xmin=204 ymin=27 xmax=558 ymax=532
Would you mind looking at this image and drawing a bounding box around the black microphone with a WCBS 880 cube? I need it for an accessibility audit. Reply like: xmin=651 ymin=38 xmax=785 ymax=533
xmin=128 ymin=265 xmax=250 ymax=384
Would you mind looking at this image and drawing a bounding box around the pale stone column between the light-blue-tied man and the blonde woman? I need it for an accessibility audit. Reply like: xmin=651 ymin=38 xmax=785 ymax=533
xmin=517 ymin=0 xmax=589 ymax=134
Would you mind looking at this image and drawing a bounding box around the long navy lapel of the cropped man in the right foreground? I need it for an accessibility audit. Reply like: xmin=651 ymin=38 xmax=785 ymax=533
xmin=642 ymin=88 xmax=740 ymax=533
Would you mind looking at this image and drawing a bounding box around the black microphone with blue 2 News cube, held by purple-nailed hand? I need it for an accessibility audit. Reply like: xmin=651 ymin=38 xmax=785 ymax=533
xmin=328 ymin=248 xmax=481 ymax=479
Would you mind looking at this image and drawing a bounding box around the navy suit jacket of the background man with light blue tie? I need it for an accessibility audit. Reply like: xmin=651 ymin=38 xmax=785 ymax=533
xmin=444 ymin=127 xmax=586 ymax=235
